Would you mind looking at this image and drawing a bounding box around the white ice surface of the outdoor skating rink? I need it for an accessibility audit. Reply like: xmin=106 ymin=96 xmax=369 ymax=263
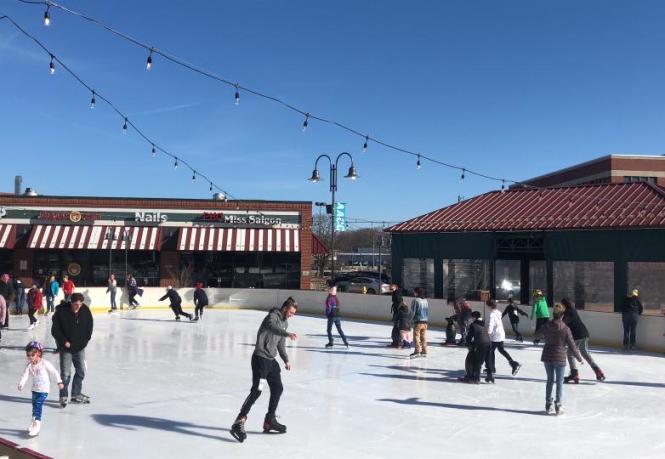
xmin=0 ymin=310 xmax=665 ymax=459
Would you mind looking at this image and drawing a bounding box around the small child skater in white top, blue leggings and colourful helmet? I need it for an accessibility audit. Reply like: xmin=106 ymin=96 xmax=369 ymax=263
xmin=18 ymin=341 xmax=65 ymax=437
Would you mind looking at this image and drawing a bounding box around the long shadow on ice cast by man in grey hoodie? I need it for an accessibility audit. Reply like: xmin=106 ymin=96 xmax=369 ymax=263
xmin=92 ymin=414 xmax=241 ymax=443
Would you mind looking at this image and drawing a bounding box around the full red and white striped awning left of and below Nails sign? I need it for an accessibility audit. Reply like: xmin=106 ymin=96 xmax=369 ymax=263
xmin=28 ymin=225 xmax=160 ymax=250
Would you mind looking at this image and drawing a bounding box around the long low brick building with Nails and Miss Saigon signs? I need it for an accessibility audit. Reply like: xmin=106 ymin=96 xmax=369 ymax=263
xmin=0 ymin=194 xmax=312 ymax=289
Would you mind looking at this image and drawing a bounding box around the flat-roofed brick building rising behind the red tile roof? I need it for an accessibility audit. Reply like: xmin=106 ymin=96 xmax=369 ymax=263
xmin=513 ymin=155 xmax=665 ymax=188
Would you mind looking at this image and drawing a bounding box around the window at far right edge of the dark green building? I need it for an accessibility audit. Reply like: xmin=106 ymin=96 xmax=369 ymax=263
xmin=626 ymin=262 xmax=665 ymax=315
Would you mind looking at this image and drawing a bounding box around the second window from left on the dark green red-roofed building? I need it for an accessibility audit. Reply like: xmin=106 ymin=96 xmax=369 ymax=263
xmin=443 ymin=259 xmax=488 ymax=300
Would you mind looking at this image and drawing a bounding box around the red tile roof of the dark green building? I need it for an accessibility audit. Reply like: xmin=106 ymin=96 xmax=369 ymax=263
xmin=386 ymin=182 xmax=665 ymax=233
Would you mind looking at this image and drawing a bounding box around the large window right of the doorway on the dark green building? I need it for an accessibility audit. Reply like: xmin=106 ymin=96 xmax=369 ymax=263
xmin=553 ymin=261 xmax=614 ymax=312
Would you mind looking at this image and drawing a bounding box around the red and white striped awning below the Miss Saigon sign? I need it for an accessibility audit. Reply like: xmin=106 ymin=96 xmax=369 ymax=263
xmin=178 ymin=227 xmax=300 ymax=252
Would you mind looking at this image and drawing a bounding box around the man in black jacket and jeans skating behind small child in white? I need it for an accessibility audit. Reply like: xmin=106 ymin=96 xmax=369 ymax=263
xmin=51 ymin=293 xmax=93 ymax=408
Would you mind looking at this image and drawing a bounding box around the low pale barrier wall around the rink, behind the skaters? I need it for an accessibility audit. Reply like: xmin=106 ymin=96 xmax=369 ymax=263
xmin=16 ymin=287 xmax=665 ymax=352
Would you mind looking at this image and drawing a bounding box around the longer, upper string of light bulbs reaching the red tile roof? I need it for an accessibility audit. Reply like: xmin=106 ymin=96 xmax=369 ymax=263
xmin=13 ymin=0 xmax=528 ymax=188
